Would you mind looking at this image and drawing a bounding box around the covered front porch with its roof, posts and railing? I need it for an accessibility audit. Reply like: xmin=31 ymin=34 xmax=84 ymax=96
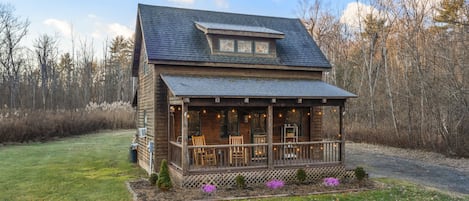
xmin=161 ymin=75 xmax=355 ymax=187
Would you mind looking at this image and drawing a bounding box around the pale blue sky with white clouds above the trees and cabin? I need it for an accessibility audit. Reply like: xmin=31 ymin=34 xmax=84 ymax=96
xmin=0 ymin=0 xmax=364 ymax=55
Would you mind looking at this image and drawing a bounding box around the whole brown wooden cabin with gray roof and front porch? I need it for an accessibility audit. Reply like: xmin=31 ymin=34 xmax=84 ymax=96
xmin=132 ymin=4 xmax=356 ymax=187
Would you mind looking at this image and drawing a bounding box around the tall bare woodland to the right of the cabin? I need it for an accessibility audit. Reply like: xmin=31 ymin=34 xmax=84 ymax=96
xmin=299 ymin=0 xmax=469 ymax=157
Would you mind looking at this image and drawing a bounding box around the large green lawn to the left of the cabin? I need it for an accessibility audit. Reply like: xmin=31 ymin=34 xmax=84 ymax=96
xmin=0 ymin=131 xmax=144 ymax=200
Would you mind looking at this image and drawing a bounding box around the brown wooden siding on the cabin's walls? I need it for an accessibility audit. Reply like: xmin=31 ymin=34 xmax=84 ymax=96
xmin=141 ymin=62 xmax=322 ymax=171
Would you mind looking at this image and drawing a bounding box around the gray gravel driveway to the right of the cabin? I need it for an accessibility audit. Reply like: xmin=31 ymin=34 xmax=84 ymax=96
xmin=345 ymin=142 xmax=469 ymax=195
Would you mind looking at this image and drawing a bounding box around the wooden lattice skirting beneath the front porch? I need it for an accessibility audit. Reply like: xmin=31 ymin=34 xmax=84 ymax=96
xmin=171 ymin=165 xmax=355 ymax=188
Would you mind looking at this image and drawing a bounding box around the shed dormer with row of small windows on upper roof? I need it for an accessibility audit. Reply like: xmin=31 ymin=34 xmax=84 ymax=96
xmin=195 ymin=22 xmax=285 ymax=57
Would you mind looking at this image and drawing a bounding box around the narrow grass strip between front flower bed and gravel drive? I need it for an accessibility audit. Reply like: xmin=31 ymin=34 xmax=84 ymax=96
xmin=254 ymin=178 xmax=469 ymax=201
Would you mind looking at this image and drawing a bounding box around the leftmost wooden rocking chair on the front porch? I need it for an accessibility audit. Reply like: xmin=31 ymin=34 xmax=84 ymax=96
xmin=192 ymin=135 xmax=217 ymax=165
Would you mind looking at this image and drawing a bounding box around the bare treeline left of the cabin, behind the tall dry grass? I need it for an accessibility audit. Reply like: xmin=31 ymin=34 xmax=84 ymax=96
xmin=0 ymin=3 xmax=133 ymax=110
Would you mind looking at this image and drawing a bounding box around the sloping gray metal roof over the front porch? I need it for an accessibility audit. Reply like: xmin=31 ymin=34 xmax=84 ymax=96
xmin=161 ymin=75 xmax=357 ymax=99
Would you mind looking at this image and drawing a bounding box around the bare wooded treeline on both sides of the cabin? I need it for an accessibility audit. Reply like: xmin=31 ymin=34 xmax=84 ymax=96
xmin=0 ymin=0 xmax=469 ymax=156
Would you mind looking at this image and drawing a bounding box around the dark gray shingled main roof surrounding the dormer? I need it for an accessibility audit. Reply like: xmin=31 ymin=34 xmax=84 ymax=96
xmin=138 ymin=4 xmax=331 ymax=69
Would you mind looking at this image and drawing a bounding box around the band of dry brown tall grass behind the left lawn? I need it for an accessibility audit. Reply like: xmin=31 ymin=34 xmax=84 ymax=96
xmin=0 ymin=102 xmax=135 ymax=143
